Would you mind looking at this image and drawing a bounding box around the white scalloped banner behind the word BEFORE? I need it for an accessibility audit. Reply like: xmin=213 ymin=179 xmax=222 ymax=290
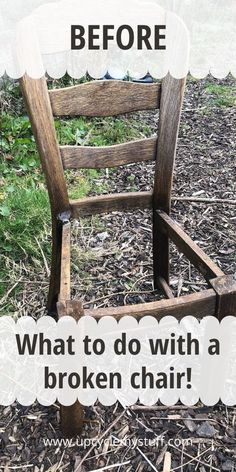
xmin=0 ymin=0 xmax=236 ymax=78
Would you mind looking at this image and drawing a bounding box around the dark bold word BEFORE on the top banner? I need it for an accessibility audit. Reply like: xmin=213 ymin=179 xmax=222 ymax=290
xmin=71 ymin=25 xmax=166 ymax=51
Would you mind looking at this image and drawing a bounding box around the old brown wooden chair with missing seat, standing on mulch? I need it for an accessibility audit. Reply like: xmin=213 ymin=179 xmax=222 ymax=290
xmin=21 ymin=75 xmax=236 ymax=435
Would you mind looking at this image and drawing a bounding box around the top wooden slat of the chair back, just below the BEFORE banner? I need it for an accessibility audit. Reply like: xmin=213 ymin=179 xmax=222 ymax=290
xmin=49 ymin=80 xmax=160 ymax=116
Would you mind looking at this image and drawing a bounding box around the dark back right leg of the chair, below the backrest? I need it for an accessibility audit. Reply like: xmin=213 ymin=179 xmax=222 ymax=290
xmin=153 ymin=210 xmax=169 ymax=290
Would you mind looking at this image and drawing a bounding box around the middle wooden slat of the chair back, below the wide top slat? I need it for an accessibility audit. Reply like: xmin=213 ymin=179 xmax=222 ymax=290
xmin=60 ymin=137 xmax=157 ymax=169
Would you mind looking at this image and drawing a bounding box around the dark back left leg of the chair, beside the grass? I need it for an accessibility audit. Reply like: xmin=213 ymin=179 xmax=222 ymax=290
xmin=47 ymin=218 xmax=62 ymax=317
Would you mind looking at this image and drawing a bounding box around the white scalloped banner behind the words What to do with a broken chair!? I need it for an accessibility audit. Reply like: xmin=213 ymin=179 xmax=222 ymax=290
xmin=0 ymin=316 xmax=236 ymax=407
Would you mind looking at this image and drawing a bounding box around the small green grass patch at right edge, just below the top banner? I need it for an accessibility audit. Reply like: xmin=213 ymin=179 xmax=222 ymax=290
xmin=206 ymin=84 xmax=236 ymax=107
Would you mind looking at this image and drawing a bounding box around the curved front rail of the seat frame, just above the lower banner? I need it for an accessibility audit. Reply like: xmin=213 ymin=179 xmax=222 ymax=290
xmin=84 ymin=289 xmax=216 ymax=320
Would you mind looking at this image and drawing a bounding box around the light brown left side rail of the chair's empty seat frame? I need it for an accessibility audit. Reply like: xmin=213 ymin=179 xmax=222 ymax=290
xmin=59 ymin=223 xmax=71 ymax=302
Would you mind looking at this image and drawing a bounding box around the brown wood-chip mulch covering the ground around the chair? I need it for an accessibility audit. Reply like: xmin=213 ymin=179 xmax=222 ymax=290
xmin=0 ymin=77 xmax=236 ymax=472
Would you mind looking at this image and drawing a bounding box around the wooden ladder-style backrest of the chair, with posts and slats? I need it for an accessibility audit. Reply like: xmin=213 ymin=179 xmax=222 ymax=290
xmin=21 ymin=74 xmax=185 ymax=217
